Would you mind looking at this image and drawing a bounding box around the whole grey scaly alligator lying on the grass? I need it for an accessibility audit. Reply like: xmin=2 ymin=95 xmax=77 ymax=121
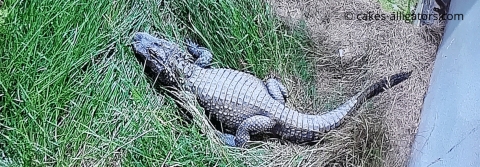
xmin=132 ymin=32 xmax=412 ymax=147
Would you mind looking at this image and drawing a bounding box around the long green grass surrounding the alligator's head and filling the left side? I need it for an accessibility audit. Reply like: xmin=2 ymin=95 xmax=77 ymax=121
xmin=0 ymin=0 xmax=313 ymax=166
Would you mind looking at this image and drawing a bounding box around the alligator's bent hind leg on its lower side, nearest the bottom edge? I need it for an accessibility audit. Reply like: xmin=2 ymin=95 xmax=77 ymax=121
xmin=220 ymin=115 xmax=276 ymax=147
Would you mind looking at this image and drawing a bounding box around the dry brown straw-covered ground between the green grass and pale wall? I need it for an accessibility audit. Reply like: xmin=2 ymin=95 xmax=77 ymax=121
xmin=268 ymin=0 xmax=443 ymax=166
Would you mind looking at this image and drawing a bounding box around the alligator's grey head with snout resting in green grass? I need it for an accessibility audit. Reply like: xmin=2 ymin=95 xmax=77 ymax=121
xmin=133 ymin=32 xmax=182 ymax=86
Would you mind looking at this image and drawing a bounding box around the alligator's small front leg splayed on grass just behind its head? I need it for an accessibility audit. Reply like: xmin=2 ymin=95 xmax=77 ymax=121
xmin=185 ymin=39 xmax=213 ymax=68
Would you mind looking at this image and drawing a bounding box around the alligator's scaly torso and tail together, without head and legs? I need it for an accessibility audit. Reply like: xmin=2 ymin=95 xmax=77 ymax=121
xmin=187 ymin=69 xmax=411 ymax=143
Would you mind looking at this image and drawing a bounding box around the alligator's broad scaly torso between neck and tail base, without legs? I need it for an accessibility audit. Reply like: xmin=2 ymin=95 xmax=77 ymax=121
xmin=187 ymin=69 xmax=280 ymax=130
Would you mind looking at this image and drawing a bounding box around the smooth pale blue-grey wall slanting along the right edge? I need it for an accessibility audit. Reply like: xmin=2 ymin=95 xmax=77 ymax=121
xmin=409 ymin=0 xmax=480 ymax=167
